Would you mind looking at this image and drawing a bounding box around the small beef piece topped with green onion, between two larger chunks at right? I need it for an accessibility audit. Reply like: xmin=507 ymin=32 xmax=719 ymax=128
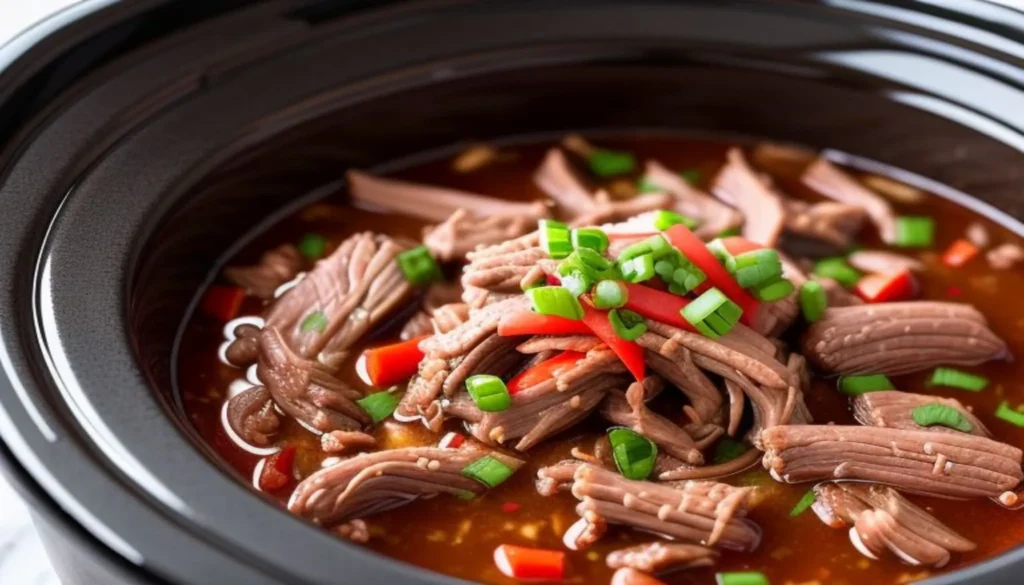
xmin=853 ymin=390 xmax=992 ymax=436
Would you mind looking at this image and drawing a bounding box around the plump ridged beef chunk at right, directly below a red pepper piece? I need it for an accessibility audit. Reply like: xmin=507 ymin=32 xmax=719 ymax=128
xmin=803 ymin=301 xmax=1007 ymax=374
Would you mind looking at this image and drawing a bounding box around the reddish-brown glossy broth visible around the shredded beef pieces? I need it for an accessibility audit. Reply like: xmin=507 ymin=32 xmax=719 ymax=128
xmin=177 ymin=137 xmax=1024 ymax=585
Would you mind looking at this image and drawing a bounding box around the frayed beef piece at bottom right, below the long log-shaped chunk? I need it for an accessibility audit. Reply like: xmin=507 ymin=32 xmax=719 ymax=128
xmin=813 ymin=483 xmax=975 ymax=568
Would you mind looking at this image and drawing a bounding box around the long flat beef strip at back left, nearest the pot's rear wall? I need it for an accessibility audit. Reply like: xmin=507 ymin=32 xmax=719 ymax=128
xmin=346 ymin=170 xmax=547 ymax=222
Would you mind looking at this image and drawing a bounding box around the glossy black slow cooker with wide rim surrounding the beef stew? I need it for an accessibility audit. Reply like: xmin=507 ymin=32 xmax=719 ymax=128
xmin=0 ymin=0 xmax=1024 ymax=585
